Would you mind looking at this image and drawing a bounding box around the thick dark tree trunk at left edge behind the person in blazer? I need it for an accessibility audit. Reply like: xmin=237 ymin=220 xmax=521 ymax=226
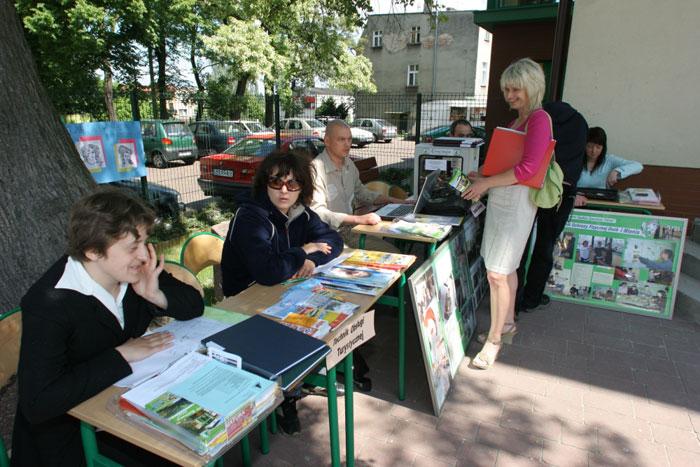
xmin=0 ymin=0 xmax=95 ymax=311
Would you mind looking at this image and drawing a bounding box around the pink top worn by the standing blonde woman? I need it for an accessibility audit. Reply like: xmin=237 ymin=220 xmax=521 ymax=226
xmin=513 ymin=109 xmax=552 ymax=182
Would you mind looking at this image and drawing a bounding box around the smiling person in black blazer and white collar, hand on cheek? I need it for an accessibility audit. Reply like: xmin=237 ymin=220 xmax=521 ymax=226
xmin=12 ymin=188 xmax=204 ymax=467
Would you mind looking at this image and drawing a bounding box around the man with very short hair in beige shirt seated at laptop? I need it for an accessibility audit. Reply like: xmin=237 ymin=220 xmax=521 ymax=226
xmin=311 ymin=120 xmax=410 ymax=253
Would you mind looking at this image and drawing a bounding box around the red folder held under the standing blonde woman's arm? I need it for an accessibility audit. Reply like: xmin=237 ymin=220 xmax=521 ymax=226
xmin=481 ymin=126 xmax=557 ymax=189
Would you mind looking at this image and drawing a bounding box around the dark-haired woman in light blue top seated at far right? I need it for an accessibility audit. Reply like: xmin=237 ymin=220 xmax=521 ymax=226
xmin=575 ymin=126 xmax=644 ymax=206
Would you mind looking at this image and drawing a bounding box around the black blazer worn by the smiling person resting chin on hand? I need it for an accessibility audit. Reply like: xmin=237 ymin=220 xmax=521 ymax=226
xmin=11 ymin=257 xmax=204 ymax=466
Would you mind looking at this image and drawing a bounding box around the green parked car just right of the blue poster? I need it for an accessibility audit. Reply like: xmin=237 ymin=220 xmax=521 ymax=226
xmin=141 ymin=120 xmax=198 ymax=169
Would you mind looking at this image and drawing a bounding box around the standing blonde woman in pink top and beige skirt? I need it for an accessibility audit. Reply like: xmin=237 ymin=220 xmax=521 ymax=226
xmin=463 ymin=58 xmax=552 ymax=369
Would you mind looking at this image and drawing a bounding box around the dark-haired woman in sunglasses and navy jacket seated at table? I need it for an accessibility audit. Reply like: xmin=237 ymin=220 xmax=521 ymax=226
xmin=221 ymin=151 xmax=343 ymax=434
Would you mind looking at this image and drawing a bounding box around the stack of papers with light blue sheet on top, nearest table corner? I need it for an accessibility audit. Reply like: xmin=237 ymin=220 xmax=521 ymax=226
xmin=120 ymin=352 xmax=277 ymax=455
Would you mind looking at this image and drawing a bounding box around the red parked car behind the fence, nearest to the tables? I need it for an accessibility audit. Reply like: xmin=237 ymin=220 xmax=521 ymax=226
xmin=197 ymin=133 xmax=326 ymax=196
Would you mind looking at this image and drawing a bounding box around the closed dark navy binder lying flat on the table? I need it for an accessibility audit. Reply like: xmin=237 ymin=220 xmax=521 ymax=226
xmin=202 ymin=315 xmax=331 ymax=390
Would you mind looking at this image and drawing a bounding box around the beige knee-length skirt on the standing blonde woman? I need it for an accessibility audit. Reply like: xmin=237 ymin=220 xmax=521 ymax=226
xmin=481 ymin=185 xmax=537 ymax=274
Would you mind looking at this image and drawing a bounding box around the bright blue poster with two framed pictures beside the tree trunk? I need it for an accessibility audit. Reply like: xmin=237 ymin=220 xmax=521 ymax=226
xmin=66 ymin=122 xmax=146 ymax=183
